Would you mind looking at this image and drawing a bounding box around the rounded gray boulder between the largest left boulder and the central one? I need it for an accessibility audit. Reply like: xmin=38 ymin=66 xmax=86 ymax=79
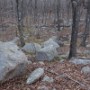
xmin=22 ymin=43 xmax=41 ymax=53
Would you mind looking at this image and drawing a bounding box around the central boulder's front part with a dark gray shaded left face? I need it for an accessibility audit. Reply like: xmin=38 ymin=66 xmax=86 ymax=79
xmin=36 ymin=45 xmax=58 ymax=61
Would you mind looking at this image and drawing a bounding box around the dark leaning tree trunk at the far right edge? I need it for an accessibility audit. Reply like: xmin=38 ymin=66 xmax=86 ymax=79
xmin=81 ymin=0 xmax=90 ymax=47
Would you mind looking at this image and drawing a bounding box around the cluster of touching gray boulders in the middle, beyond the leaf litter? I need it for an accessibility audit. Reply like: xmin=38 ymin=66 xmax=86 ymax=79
xmin=22 ymin=36 xmax=60 ymax=61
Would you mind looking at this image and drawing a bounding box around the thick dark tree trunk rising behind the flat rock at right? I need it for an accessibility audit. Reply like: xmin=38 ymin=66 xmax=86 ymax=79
xmin=69 ymin=0 xmax=80 ymax=59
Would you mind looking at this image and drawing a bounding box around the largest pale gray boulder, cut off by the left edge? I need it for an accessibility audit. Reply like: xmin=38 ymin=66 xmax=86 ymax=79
xmin=0 ymin=42 xmax=28 ymax=83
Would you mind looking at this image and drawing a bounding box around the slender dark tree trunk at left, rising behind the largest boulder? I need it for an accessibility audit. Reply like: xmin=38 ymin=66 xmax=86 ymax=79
xmin=16 ymin=0 xmax=25 ymax=46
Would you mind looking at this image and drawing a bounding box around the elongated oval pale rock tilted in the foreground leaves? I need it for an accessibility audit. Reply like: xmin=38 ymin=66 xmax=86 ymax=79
xmin=26 ymin=68 xmax=44 ymax=84
